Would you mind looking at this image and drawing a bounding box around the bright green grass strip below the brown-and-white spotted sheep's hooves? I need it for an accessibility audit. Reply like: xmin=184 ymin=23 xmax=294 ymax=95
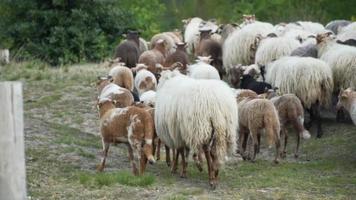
xmin=78 ymin=171 xmax=155 ymax=187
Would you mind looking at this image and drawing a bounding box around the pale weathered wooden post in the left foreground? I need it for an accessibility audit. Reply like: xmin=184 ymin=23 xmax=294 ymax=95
xmin=0 ymin=82 xmax=27 ymax=200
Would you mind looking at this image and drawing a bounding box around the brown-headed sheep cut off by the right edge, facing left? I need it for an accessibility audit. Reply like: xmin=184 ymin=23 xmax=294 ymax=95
xmin=336 ymin=88 xmax=356 ymax=125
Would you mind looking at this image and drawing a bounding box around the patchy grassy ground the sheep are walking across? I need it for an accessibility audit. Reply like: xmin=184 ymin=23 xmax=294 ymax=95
xmin=0 ymin=61 xmax=356 ymax=200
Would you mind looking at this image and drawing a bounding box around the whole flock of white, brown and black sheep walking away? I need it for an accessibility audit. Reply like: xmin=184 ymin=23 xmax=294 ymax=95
xmin=97 ymin=15 xmax=356 ymax=188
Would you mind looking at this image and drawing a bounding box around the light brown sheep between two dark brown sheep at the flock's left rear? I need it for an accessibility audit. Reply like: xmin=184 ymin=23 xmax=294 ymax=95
xmin=138 ymin=39 xmax=167 ymax=74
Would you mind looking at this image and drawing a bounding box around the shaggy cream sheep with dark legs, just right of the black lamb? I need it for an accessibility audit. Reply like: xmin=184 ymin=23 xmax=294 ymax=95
xmin=266 ymin=56 xmax=334 ymax=138
